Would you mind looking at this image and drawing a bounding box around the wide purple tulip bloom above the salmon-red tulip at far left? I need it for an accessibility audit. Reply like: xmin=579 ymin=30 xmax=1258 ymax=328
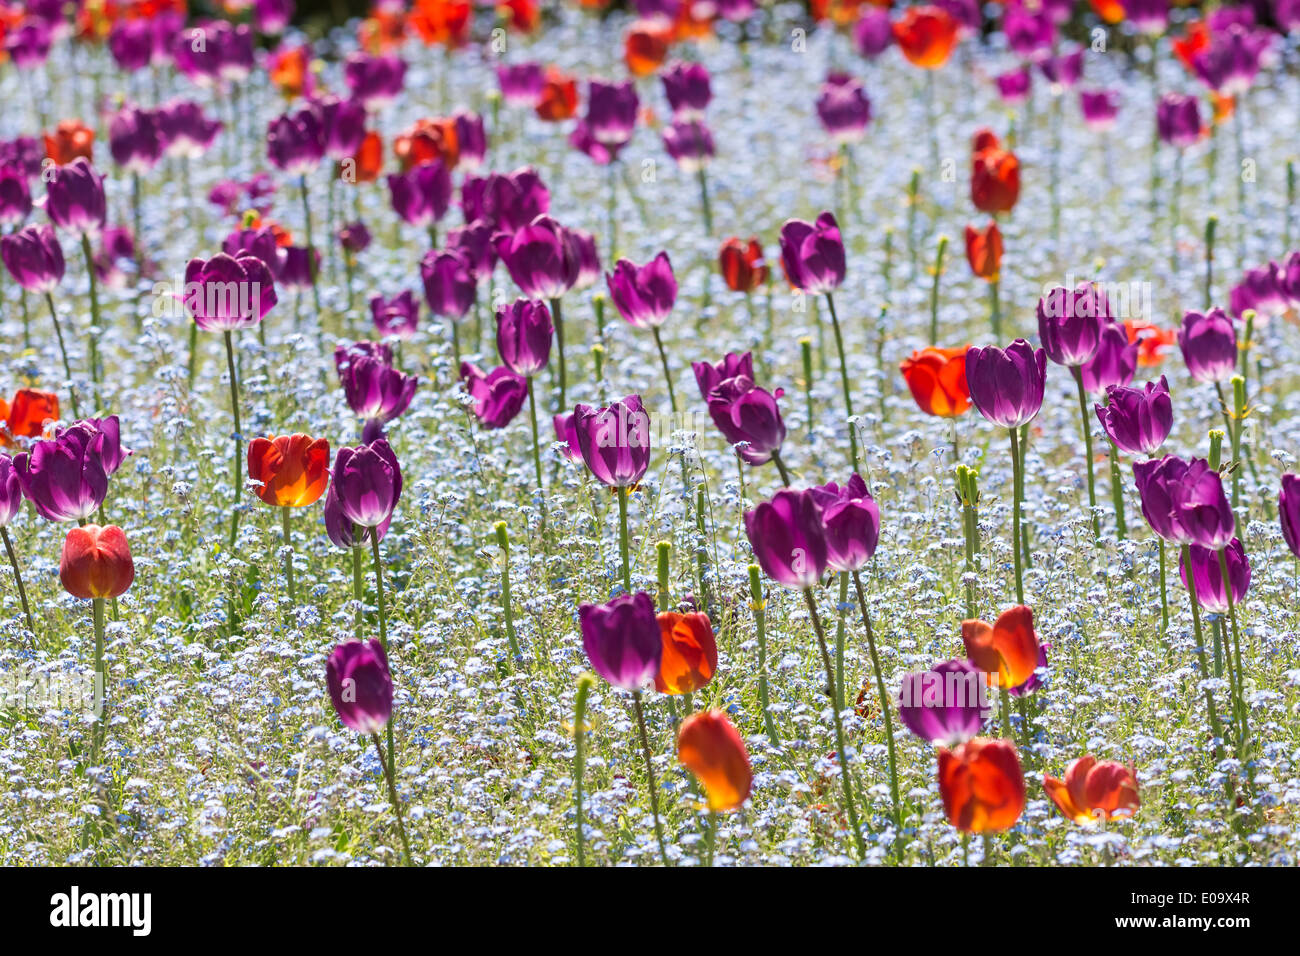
xmin=13 ymin=423 xmax=110 ymax=522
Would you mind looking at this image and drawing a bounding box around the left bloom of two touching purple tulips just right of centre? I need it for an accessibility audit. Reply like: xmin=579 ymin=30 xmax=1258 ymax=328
xmin=745 ymin=488 xmax=828 ymax=588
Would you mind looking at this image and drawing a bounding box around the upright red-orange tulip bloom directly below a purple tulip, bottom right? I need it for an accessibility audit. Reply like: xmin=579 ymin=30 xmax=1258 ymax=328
xmin=939 ymin=737 xmax=1024 ymax=834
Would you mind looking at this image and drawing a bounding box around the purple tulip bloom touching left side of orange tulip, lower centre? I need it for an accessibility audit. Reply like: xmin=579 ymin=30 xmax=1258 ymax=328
xmin=577 ymin=591 xmax=663 ymax=691
